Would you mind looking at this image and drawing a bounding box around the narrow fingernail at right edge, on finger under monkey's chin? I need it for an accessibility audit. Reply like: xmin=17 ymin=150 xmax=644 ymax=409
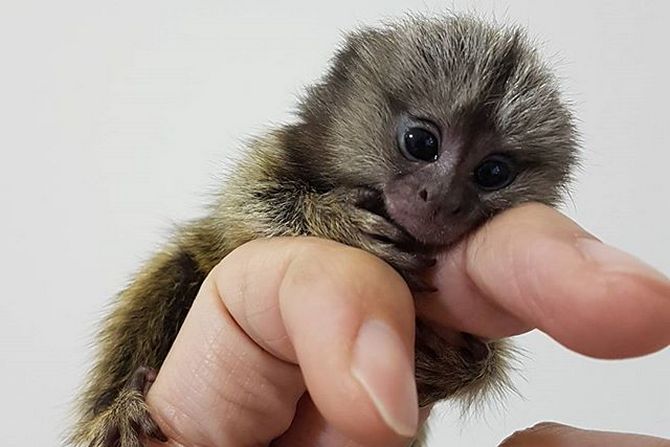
xmin=576 ymin=238 xmax=668 ymax=281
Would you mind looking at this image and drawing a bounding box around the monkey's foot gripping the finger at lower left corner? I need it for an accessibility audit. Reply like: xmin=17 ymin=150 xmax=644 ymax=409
xmin=89 ymin=367 xmax=167 ymax=447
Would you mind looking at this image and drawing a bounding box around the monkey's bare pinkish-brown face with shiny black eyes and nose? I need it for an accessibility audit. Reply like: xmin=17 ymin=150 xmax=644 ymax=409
xmin=382 ymin=117 xmax=520 ymax=245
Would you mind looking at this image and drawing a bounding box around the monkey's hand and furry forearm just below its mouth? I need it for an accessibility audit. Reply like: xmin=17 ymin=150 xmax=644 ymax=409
xmin=312 ymin=187 xmax=436 ymax=292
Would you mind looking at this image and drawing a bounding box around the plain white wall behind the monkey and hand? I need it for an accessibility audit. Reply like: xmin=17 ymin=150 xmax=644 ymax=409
xmin=0 ymin=0 xmax=670 ymax=446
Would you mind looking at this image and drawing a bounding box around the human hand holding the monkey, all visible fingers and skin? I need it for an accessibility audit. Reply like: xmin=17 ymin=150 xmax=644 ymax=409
xmin=147 ymin=204 xmax=670 ymax=447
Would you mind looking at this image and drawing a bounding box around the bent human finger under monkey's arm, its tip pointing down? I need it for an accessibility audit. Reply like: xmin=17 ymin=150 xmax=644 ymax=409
xmin=147 ymin=238 xmax=418 ymax=445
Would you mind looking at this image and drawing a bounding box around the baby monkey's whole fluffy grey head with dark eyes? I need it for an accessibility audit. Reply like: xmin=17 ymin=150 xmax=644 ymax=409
xmin=293 ymin=16 xmax=577 ymax=246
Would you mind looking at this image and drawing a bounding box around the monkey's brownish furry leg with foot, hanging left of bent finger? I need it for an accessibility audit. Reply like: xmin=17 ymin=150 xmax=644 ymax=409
xmin=70 ymin=248 xmax=205 ymax=447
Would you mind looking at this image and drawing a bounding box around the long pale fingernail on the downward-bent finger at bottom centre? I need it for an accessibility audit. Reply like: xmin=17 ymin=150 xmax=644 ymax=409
xmin=351 ymin=320 xmax=419 ymax=437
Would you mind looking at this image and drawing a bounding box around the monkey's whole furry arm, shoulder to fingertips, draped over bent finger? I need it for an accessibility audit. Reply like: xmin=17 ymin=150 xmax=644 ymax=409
xmin=226 ymin=180 xmax=435 ymax=291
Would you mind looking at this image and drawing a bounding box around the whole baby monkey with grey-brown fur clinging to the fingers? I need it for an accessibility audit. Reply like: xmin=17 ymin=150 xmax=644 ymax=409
xmin=70 ymin=16 xmax=577 ymax=447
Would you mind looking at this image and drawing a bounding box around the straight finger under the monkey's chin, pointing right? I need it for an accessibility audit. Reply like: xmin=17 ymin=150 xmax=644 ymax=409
xmin=419 ymin=204 xmax=670 ymax=358
